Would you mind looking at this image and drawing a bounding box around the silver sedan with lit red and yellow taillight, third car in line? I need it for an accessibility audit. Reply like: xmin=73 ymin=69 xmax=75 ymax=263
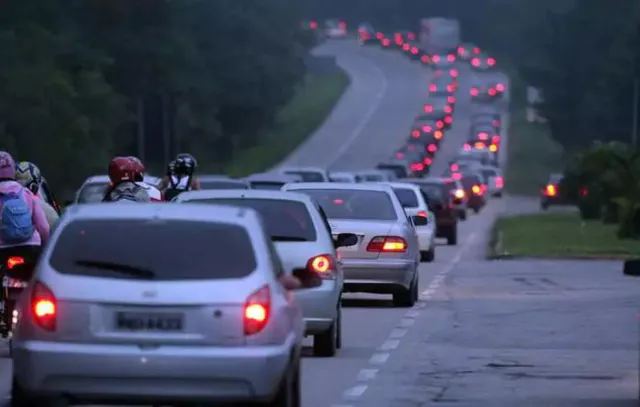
xmin=283 ymin=182 xmax=426 ymax=307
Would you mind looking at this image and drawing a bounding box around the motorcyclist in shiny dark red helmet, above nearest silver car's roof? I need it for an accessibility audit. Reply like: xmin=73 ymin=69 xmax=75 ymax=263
xmin=102 ymin=157 xmax=151 ymax=202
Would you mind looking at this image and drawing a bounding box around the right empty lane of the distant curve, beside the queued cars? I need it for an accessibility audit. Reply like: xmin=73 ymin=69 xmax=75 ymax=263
xmin=327 ymin=47 xmax=431 ymax=171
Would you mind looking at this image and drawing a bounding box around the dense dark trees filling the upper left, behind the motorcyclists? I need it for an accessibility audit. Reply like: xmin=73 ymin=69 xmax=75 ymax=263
xmin=0 ymin=0 xmax=311 ymax=193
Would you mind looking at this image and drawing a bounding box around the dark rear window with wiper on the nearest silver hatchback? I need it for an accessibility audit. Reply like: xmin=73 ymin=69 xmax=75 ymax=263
xmin=49 ymin=219 xmax=256 ymax=281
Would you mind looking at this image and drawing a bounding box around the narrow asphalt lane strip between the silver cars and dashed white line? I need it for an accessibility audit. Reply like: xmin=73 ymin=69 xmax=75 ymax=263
xmin=302 ymin=199 xmax=500 ymax=407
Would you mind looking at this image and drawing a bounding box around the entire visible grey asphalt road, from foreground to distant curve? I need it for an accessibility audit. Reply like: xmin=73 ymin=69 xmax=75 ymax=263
xmin=0 ymin=41 xmax=640 ymax=407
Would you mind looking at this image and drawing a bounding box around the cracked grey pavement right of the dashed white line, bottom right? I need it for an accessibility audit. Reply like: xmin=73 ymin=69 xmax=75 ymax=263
xmin=350 ymin=260 xmax=640 ymax=407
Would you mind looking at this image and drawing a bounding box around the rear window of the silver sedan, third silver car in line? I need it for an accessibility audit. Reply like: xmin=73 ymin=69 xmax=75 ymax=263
xmin=295 ymin=189 xmax=398 ymax=220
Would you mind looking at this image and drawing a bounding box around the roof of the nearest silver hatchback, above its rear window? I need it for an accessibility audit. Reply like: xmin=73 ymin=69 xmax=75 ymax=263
xmin=61 ymin=202 xmax=258 ymax=227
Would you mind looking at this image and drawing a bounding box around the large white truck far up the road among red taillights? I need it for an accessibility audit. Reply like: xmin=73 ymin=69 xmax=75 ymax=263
xmin=420 ymin=17 xmax=460 ymax=55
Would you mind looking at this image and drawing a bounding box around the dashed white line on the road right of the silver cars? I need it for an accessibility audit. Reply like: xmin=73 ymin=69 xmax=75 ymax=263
xmin=332 ymin=233 xmax=477 ymax=407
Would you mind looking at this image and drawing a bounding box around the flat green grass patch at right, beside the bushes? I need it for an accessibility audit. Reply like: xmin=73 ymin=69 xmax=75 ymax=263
xmin=489 ymin=212 xmax=640 ymax=259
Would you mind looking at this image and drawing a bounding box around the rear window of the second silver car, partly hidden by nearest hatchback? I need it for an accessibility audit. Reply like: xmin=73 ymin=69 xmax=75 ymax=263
xmin=183 ymin=198 xmax=317 ymax=242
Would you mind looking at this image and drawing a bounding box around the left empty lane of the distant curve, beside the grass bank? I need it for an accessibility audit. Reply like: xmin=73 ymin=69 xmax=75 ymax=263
xmin=279 ymin=40 xmax=389 ymax=167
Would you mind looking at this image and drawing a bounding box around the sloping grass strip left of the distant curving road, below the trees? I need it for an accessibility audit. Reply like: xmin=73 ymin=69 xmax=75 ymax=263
xmin=224 ymin=70 xmax=349 ymax=177
